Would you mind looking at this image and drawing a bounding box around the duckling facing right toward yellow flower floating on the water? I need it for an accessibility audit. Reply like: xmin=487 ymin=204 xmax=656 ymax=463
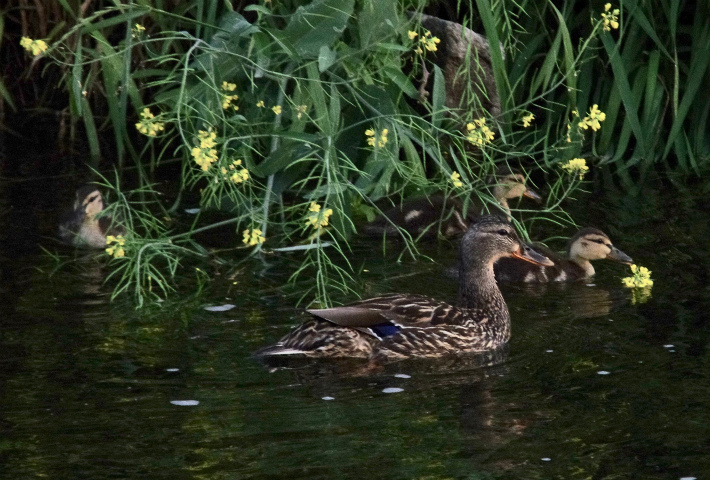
xmin=494 ymin=228 xmax=633 ymax=283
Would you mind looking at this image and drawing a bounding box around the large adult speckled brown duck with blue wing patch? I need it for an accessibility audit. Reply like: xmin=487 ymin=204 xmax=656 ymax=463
xmin=257 ymin=215 xmax=552 ymax=361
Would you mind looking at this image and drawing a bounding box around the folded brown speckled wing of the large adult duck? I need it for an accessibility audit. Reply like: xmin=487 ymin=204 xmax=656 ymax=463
xmin=308 ymin=294 xmax=462 ymax=328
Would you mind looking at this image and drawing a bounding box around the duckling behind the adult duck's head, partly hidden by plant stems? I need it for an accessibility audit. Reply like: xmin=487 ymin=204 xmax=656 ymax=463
xmin=363 ymin=169 xmax=542 ymax=238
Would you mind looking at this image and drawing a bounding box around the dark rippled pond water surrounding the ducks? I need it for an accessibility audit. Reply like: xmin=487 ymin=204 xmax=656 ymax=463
xmin=0 ymin=173 xmax=710 ymax=480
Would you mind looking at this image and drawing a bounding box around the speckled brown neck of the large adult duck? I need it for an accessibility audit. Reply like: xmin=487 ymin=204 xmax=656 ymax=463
xmin=459 ymin=259 xmax=510 ymax=323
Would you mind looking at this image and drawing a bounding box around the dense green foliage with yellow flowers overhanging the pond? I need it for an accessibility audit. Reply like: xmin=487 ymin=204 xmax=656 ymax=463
xmin=0 ymin=0 xmax=710 ymax=303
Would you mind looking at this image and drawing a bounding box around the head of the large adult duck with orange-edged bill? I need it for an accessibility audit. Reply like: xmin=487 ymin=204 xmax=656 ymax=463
xmin=461 ymin=215 xmax=554 ymax=272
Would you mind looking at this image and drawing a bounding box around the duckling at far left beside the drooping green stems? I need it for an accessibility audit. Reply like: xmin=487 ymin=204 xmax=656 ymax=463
xmin=59 ymin=185 xmax=124 ymax=248
